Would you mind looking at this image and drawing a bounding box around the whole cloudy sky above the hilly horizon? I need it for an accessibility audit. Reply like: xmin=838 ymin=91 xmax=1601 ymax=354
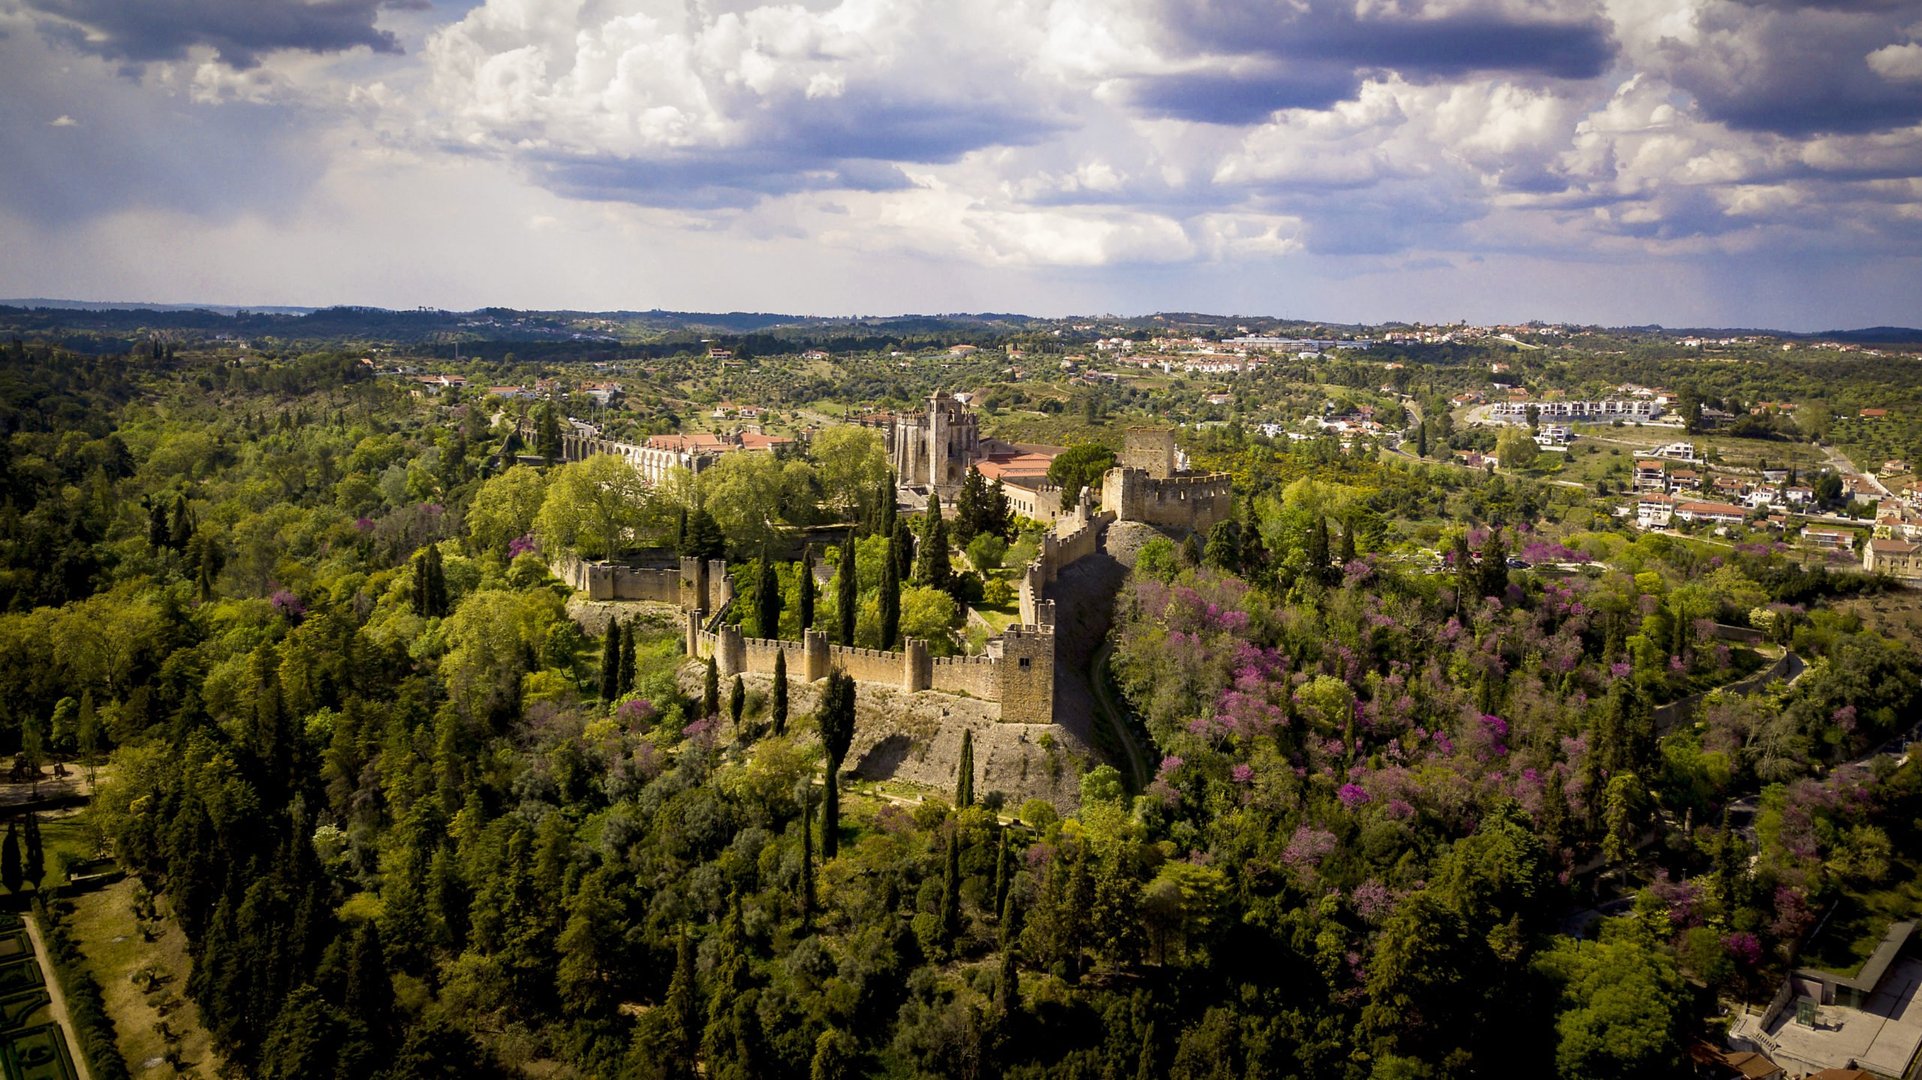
xmin=0 ymin=0 xmax=1922 ymax=331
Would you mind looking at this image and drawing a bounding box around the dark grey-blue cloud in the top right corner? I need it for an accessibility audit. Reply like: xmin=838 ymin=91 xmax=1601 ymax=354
xmin=1663 ymin=4 xmax=1922 ymax=136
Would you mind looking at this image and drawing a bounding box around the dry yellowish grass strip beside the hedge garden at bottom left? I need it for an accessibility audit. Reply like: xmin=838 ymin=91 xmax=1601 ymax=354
xmin=69 ymin=878 xmax=219 ymax=1080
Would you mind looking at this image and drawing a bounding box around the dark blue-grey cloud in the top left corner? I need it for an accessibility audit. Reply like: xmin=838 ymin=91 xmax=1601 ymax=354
xmin=25 ymin=0 xmax=425 ymax=67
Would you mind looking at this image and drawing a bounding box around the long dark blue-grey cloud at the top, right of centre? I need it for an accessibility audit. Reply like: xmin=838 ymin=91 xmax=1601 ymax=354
xmin=1130 ymin=0 xmax=1614 ymax=125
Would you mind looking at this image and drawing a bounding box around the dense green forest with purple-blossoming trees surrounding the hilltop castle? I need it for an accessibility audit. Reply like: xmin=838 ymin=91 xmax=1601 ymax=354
xmin=0 ymin=332 xmax=1922 ymax=1080
